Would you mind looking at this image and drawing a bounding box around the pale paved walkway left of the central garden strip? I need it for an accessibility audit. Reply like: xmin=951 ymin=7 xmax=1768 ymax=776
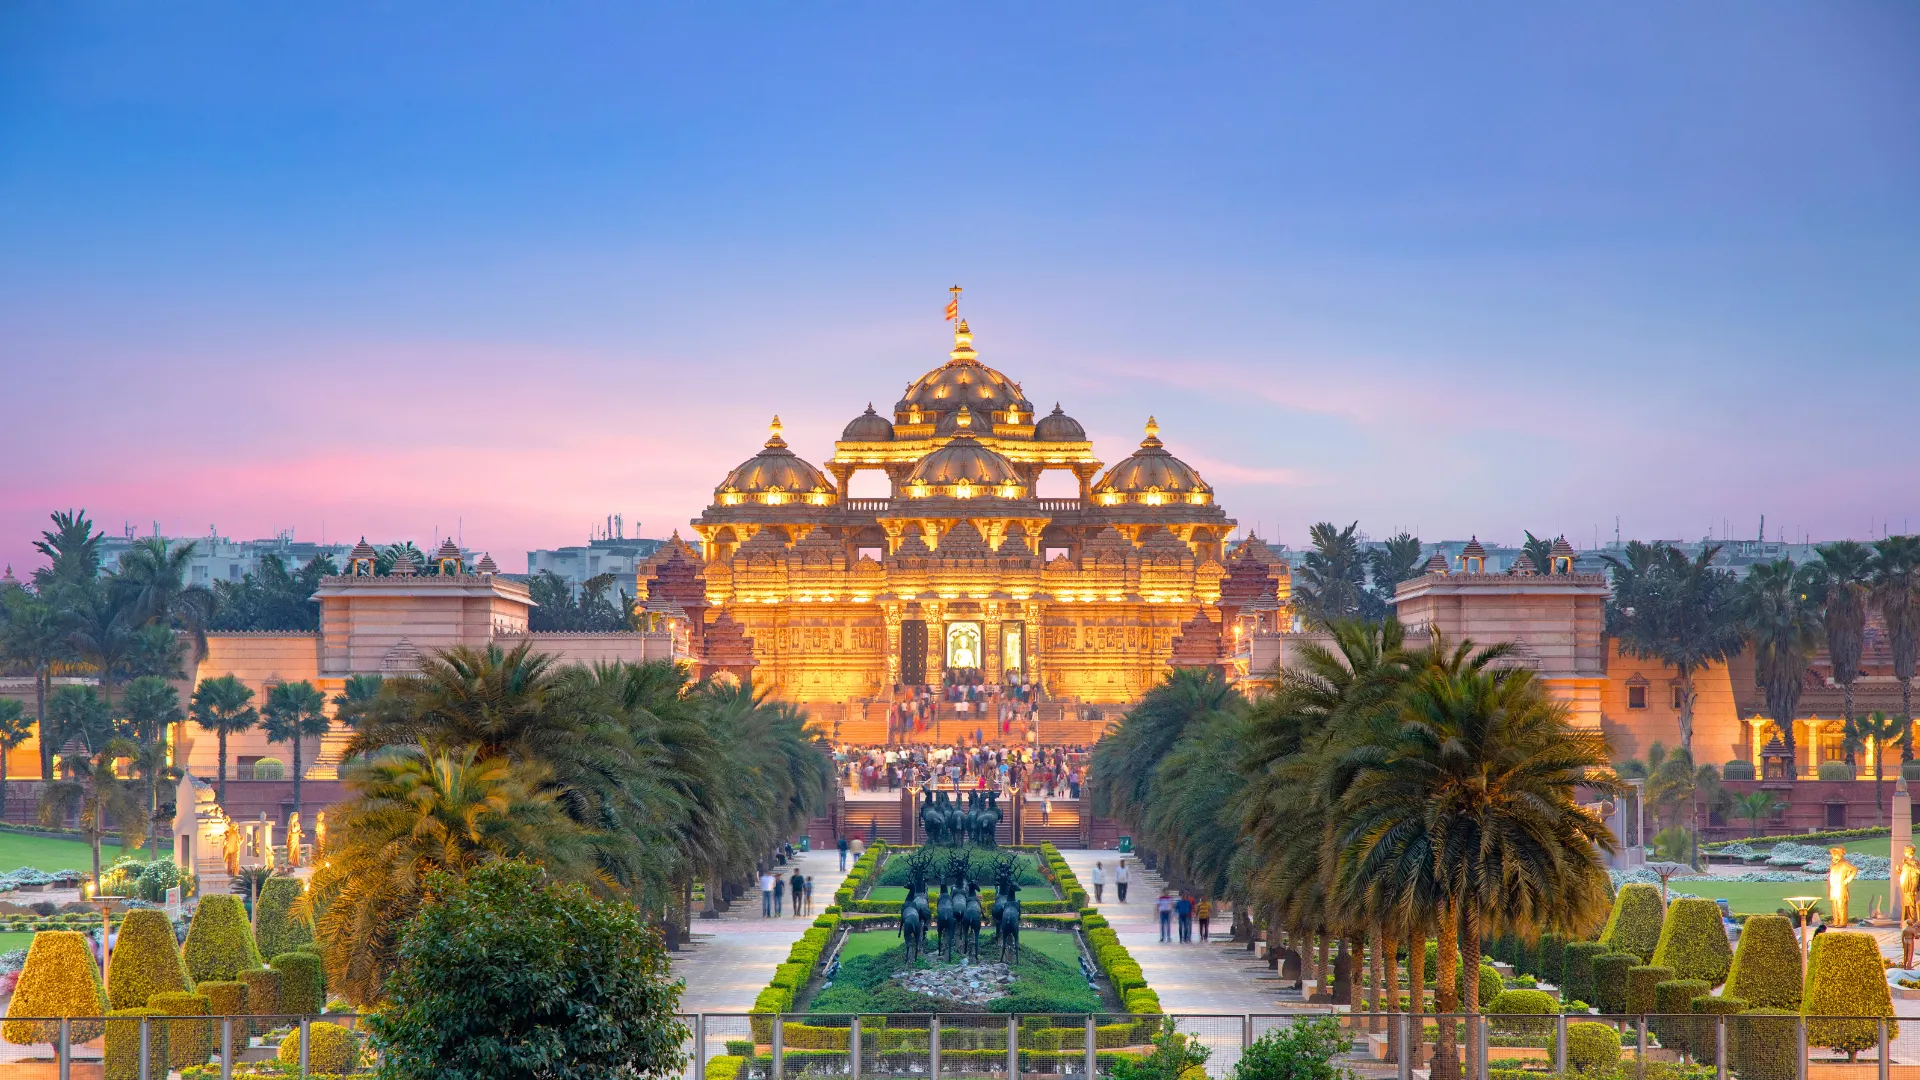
xmin=674 ymin=851 xmax=852 ymax=1013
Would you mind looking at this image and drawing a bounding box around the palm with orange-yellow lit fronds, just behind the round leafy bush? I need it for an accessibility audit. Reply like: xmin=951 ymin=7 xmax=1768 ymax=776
xmin=300 ymin=737 xmax=605 ymax=1005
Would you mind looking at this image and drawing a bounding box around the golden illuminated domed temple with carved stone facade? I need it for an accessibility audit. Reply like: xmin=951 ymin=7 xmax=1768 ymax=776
xmin=675 ymin=311 xmax=1288 ymax=721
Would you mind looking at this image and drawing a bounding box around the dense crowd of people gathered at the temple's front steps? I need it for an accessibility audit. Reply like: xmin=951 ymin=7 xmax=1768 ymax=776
xmin=833 ymin=734 xmax=1087 ymax=799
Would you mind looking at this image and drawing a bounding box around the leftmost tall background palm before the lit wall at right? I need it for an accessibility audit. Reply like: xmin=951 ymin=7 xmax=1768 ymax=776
xmin=1607 ymin=542 xmax=1751 ymax=749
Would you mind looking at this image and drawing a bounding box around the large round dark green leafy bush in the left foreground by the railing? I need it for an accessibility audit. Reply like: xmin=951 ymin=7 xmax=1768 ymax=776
xmin=367 ymin=861 xmax=689 ymax=1080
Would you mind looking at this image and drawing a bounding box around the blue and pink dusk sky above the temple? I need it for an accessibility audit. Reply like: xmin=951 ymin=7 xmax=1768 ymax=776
xmin=0 ymin=0 xmax=1920 ymax=571
